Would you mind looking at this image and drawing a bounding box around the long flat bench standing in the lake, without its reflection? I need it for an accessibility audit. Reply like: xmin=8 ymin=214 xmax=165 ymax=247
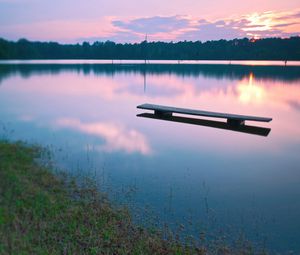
xmin=137 ymin=104 xmax=272 ymax=127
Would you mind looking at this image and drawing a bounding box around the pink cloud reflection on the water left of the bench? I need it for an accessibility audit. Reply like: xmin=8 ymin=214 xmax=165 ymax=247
xmin=56 ymin=119 xmax=151 ymax=155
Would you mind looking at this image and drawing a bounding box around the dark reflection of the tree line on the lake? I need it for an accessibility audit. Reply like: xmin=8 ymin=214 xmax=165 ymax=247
xmin=0 ymin=64 xmax=300 ymax=83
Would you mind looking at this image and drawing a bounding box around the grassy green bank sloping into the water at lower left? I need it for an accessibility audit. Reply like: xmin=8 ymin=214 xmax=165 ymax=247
xmin=0 ymin=141 xmax=260 ymax=254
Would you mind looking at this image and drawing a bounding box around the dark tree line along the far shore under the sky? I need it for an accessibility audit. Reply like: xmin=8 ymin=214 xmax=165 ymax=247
xmin=0 ymin=36 xmax=300 ymax=61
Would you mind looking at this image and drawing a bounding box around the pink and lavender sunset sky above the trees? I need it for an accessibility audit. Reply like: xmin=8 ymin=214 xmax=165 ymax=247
xmin=0 ymin=0 xmax=300 ymax=43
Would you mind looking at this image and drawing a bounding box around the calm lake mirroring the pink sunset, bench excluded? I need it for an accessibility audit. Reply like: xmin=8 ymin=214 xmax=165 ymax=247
xmin=0 ymin=60 xmax=300 ymax=254
